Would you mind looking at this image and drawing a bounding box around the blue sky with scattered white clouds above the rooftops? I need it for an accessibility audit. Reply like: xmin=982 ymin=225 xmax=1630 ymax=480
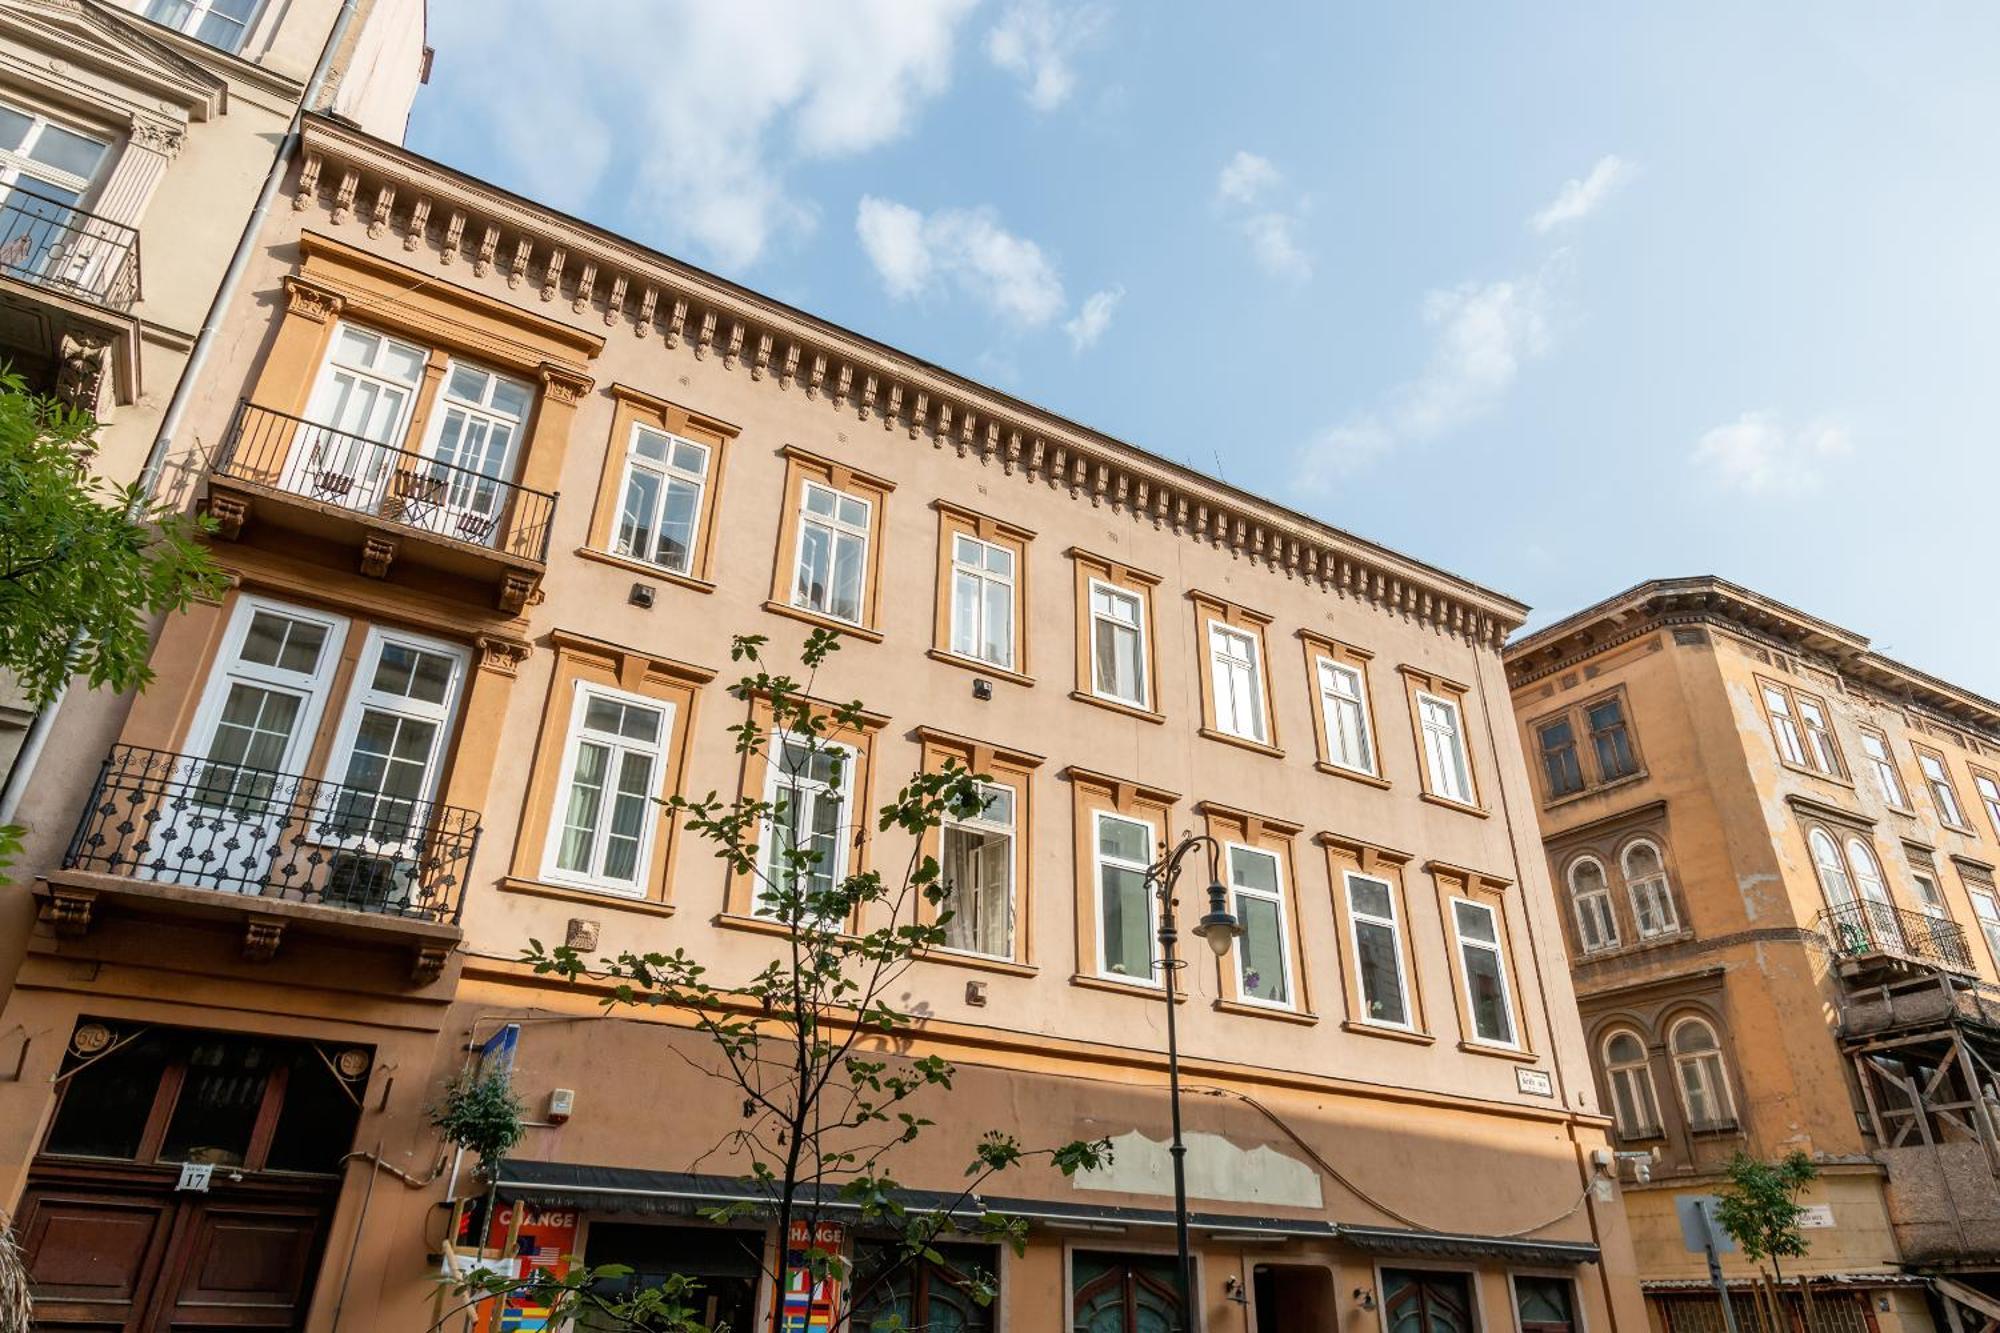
xmin=410 ymin=0 xmax=2000 ymax=697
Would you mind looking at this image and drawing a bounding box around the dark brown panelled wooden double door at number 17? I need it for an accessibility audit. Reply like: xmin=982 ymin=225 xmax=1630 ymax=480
xmin=18 ymin=1167 xmax=334 ymax=1333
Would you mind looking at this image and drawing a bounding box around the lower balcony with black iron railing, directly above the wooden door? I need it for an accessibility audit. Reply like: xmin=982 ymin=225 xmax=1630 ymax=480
xmin=42 ymin=745 xmax=480 ymax=981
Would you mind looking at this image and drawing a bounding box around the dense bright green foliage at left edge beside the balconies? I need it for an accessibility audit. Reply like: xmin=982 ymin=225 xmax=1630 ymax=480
xmin=0 ymin=372 xmax=222 ymax=707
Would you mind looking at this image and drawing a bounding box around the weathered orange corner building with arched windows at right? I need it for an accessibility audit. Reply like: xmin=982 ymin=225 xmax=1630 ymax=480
xmin=1508 ymin=578 xmax=2000 ymax=1327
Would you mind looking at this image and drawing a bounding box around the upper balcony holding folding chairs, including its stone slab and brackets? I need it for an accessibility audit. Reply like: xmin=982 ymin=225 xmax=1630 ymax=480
xmin=208 ymin=402 xmax=556 ymax=614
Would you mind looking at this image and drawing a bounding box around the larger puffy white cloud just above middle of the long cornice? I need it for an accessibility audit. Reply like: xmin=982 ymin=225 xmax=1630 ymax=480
xmin=854 ymin=194 xmax=1080 ymax=328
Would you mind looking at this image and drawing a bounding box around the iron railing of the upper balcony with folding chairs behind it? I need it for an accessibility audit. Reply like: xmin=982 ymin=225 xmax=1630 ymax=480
xmin=216 ymin=402 xmax=556 ymax=562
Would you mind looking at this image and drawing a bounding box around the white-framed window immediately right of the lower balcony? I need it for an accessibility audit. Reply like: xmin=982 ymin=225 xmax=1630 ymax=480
xmin=544 ymin=685 xmax=672 ymax=897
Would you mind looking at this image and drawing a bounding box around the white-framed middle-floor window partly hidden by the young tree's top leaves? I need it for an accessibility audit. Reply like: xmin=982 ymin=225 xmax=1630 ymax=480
xmin=750 ymin=733 xmax=856 ymax=917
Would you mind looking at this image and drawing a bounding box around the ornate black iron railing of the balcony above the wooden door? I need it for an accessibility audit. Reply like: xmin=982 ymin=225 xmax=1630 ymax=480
xmin=62 ymin=745 xmax=480 ymax=923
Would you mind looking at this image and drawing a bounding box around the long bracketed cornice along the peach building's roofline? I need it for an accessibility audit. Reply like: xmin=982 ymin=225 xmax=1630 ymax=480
xmin=292 ymin=116 xmax=1526 ymax=648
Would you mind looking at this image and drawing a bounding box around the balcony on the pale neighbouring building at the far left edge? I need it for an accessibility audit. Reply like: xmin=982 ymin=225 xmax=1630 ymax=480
xmin=0 ymin=184 xmax=140 ymax=410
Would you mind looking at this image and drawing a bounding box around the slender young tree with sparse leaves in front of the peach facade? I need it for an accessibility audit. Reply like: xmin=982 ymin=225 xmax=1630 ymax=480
xmin=460 ymin=630 xmax=1110 ymax=1333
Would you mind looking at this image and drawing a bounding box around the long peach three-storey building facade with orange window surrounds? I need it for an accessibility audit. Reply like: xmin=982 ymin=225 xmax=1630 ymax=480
xmin=0 ymin=118 xmax=1644 ymax=1333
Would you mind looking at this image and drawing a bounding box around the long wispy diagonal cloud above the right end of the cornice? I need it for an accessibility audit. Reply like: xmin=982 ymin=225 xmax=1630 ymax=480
xmin=1298 ymin=254 xmax=1562 ymax=490
